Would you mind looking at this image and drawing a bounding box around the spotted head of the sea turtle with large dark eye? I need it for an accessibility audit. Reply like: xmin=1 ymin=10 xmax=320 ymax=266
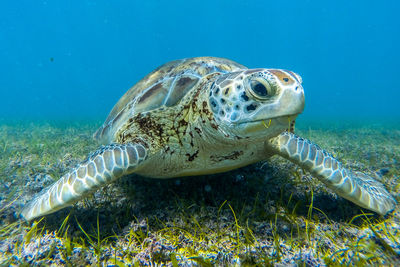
xmin=209 ymin=69 xmax=304 ymax=138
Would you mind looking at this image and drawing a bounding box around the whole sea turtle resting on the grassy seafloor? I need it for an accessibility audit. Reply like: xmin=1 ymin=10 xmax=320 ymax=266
xmin=22 ymin=57 xmax=396 ymax=220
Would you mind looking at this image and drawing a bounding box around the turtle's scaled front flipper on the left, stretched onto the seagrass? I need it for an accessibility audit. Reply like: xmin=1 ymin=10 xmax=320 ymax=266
xmin=21 ymin=144 xmax=147 ymax=221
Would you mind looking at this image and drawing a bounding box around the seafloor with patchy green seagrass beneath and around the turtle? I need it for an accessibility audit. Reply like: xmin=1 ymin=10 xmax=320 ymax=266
xmin=0 ymin=119 xmax=400 ymax=266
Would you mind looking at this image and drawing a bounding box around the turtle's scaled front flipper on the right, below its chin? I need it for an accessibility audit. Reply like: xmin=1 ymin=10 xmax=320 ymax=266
xmin=267 ymin=132 xmax=396 ymax=215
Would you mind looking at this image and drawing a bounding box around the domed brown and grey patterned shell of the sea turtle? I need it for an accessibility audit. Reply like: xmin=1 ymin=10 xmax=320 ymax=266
xmin=94 ymin=57 xmax=247 ymax=143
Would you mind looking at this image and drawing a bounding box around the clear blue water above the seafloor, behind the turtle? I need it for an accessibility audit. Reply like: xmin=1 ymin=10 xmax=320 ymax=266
xmin=0 ymin=0 xmax=400 ymax=120
